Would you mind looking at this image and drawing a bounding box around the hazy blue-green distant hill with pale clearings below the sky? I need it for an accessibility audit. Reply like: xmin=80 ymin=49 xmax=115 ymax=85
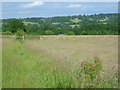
xmin=23 ymin=14 xmax=118 ymax=25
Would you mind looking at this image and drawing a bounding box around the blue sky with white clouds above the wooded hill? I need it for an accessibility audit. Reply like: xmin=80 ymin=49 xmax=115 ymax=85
xmin=2 ymin=1 xmax=118 ymax=18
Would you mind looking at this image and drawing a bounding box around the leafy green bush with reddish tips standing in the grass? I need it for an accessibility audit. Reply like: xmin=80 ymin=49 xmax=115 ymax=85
xmin=81 ymin=57 xmax=103 ymax=87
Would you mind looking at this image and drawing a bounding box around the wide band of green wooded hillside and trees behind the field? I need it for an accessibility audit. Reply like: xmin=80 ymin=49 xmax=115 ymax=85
xmin=2 ymin=14 xmax=119 ymax=35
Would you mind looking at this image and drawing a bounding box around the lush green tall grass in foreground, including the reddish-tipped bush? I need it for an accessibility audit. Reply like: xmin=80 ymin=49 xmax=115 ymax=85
xmin=2 ymin=40 xmax=118 ymax=88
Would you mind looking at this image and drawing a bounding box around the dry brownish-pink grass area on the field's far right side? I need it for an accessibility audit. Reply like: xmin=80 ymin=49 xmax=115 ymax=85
xmin=25 ymin=37 xmax=118 ymax=69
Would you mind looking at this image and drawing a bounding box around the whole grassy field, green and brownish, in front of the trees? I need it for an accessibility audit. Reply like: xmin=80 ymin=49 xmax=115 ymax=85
xmin=2 ymin=37 xmax=118 ymax=88
